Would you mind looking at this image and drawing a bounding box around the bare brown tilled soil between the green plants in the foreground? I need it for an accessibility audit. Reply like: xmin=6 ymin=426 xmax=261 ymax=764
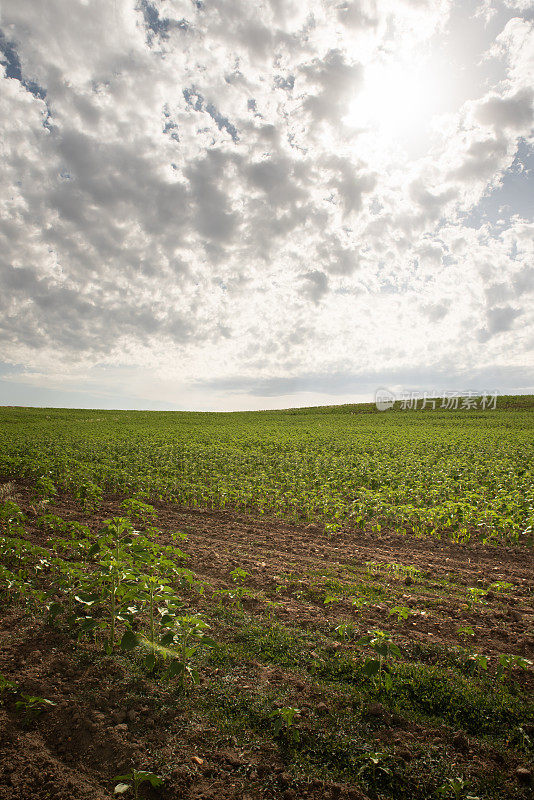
xmin=0 ymin=484 xmax=534 ymax=800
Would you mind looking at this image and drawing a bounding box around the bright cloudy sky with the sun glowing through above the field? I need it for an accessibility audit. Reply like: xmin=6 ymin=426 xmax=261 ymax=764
xmin=0 ymin=0 xmax=534 ymax=411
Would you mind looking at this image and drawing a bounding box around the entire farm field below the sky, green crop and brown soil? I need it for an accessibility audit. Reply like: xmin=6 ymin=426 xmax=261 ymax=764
xmin=0 ymin=404 xmax=534 ymax=800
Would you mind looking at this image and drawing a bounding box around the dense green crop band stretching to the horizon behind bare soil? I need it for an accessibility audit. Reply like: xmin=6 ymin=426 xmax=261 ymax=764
xmin=0 ymin=397 xmax=534 ymax=542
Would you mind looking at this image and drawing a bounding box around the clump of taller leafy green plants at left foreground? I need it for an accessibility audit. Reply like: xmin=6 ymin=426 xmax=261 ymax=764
xmin=0 ymin=498 xmax=216 ymax=691
